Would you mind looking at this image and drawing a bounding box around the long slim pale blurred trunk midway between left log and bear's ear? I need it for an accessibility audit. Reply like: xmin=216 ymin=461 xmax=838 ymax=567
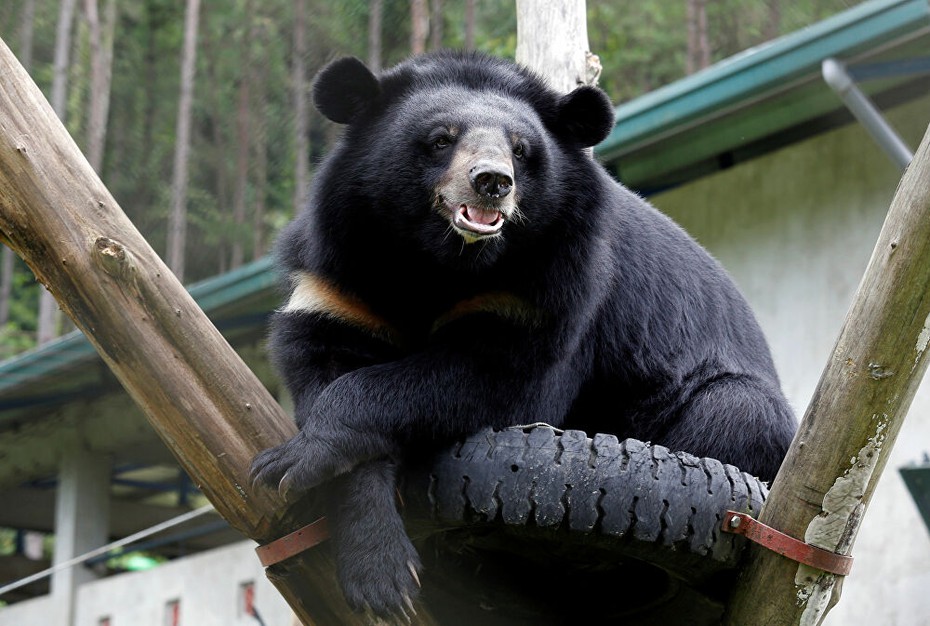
xmin=166 ymin=0 xmax=200 ymax=283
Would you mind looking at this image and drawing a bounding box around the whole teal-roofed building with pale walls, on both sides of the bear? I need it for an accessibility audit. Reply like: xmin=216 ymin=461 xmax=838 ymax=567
xmin=0 ymin=0 xmax=930 ymax=626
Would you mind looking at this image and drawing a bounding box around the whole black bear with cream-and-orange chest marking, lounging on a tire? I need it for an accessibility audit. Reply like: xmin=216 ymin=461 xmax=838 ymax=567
xmin=252 ymin=52 xmax=795 ymax=614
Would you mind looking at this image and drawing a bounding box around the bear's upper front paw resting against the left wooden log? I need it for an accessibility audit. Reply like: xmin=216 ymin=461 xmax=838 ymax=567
xmin=249 ymin=431 xmax=353 ymax=499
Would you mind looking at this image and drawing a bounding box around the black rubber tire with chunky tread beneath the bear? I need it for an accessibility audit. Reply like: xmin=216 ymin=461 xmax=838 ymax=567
xmin=401 ymin=425 xmax=768 ymax=624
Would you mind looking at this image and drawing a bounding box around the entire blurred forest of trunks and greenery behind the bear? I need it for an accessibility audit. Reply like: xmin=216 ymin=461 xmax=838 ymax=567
xmin=0 ymin=0 xmax=859 ymax=359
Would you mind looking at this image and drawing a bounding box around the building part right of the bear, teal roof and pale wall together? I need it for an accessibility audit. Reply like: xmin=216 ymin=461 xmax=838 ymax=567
xmin=598 ymin=1 xmax=930 ymax=626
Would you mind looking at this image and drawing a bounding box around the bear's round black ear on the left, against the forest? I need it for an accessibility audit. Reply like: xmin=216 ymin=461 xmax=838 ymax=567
xmin=313 ymin=57 xmax=381 ymax=124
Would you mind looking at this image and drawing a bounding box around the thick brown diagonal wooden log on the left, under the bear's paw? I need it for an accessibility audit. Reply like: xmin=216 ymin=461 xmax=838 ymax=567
xmin=0 ymin=35 xmax=432 ymax=626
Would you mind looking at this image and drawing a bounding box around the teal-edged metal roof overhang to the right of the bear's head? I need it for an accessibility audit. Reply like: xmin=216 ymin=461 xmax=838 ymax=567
xmin=595 ymin=0 xmax=930 ymax=193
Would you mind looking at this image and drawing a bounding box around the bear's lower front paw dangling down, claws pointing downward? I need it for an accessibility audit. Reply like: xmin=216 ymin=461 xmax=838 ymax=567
xmin=337 ymin=510 xmax=420 ymax=623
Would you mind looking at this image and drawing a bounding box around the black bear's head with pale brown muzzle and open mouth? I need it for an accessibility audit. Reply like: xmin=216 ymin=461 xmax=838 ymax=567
xmin=313 ymin=52 xmax=614 ymax=266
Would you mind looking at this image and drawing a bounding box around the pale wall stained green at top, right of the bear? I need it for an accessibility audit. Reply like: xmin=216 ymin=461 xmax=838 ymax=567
xmin=651 ymin=90 xmax=930 ymax=626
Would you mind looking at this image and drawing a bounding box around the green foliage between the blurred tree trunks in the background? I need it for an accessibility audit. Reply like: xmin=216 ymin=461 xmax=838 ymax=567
xmin=0 ymin=0 xmax=857 ymax=358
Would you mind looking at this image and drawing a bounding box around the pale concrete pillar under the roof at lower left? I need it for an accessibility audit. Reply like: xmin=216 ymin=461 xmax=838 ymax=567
xmin=51 ymin=446 xmax=110 ymax=626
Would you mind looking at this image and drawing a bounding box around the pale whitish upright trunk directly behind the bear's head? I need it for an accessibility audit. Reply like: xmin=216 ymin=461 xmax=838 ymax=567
xmin=517 ymin=0 xmax=600 ymax=93
